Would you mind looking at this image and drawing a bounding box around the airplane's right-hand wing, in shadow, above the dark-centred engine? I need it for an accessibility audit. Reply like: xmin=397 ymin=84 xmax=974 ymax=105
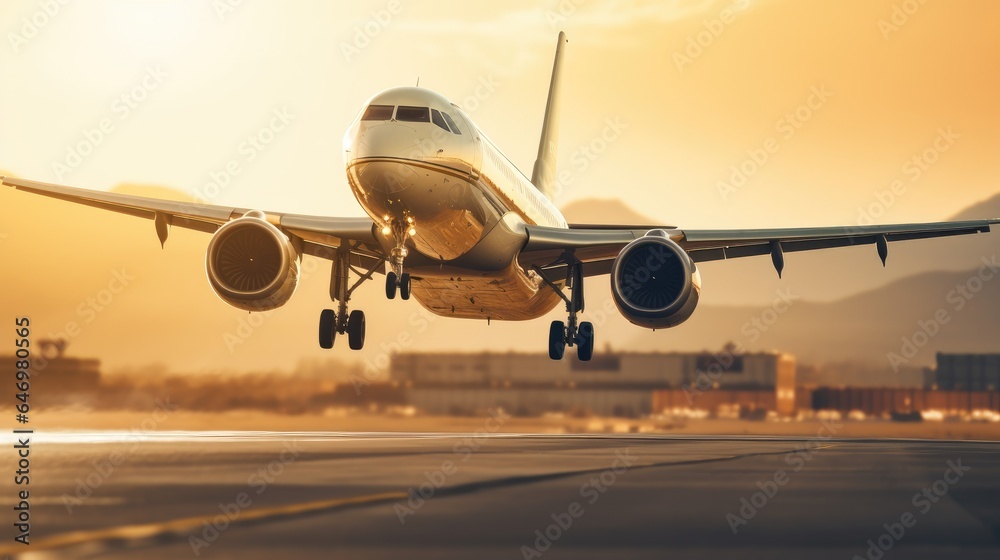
xmin=520 ymin=219 xmax=1000 ymax=277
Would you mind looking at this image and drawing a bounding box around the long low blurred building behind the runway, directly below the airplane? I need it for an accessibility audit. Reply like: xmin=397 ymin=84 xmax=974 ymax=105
xmin=390 ymin=348 xmax=795 ymax=417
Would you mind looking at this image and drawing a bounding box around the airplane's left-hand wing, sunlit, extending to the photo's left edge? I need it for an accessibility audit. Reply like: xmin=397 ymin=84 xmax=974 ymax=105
xmin=0 ymin=177 xmax=383 ymax=267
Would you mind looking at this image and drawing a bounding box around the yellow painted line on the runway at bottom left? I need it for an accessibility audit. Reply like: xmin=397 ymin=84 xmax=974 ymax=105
xmin=0 ymin=492 xmax=409 ymax=556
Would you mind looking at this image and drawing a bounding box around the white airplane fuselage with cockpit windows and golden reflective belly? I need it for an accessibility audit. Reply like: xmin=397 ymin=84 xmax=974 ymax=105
xmin=344 ymin=88 xmax=567 ymax=320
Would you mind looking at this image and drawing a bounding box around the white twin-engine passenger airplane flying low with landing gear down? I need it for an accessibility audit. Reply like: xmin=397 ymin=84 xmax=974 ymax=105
xmin=0 ymin=33 xmax=1000 ymax=361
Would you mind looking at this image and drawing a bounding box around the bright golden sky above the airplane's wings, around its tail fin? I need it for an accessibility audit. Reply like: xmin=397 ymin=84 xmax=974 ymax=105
xmin=0 ymin=0 xmax=1000 ymax=227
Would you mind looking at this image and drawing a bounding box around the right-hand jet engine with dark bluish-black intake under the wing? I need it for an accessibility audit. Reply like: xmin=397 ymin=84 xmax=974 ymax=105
xmin=611 ymin=229 xmax=701 ymax=329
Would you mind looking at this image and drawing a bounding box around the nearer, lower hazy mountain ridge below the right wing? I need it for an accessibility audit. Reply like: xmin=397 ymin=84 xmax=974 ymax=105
xmin=628 ymin=269 xmax=1000 ymax=371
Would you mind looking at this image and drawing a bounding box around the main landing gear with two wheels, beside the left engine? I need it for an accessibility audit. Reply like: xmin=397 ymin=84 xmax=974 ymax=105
xmin=319 ymin=246 xmax=385 ymax=350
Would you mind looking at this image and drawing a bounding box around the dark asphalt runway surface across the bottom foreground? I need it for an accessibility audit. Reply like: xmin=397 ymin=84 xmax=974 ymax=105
xmin=0 ymin=430 xmax=1000 ymax=560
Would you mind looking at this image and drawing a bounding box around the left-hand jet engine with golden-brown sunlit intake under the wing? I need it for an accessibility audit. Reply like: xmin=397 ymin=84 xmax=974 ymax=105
xmin=205 ymin=211 xmax=300 ymax=311
